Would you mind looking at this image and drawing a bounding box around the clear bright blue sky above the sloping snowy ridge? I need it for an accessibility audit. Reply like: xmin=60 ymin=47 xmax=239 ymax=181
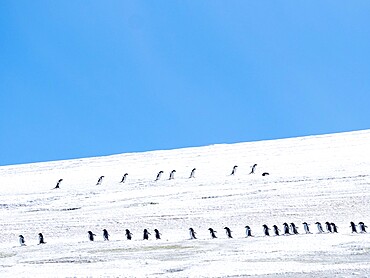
xmin=0 ymin=0 xmax=370 ymax=165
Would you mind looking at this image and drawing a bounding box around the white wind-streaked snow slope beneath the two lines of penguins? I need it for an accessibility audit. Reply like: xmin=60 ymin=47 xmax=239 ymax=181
xmin=0 ymin=131 xmax=370 ymax=277
